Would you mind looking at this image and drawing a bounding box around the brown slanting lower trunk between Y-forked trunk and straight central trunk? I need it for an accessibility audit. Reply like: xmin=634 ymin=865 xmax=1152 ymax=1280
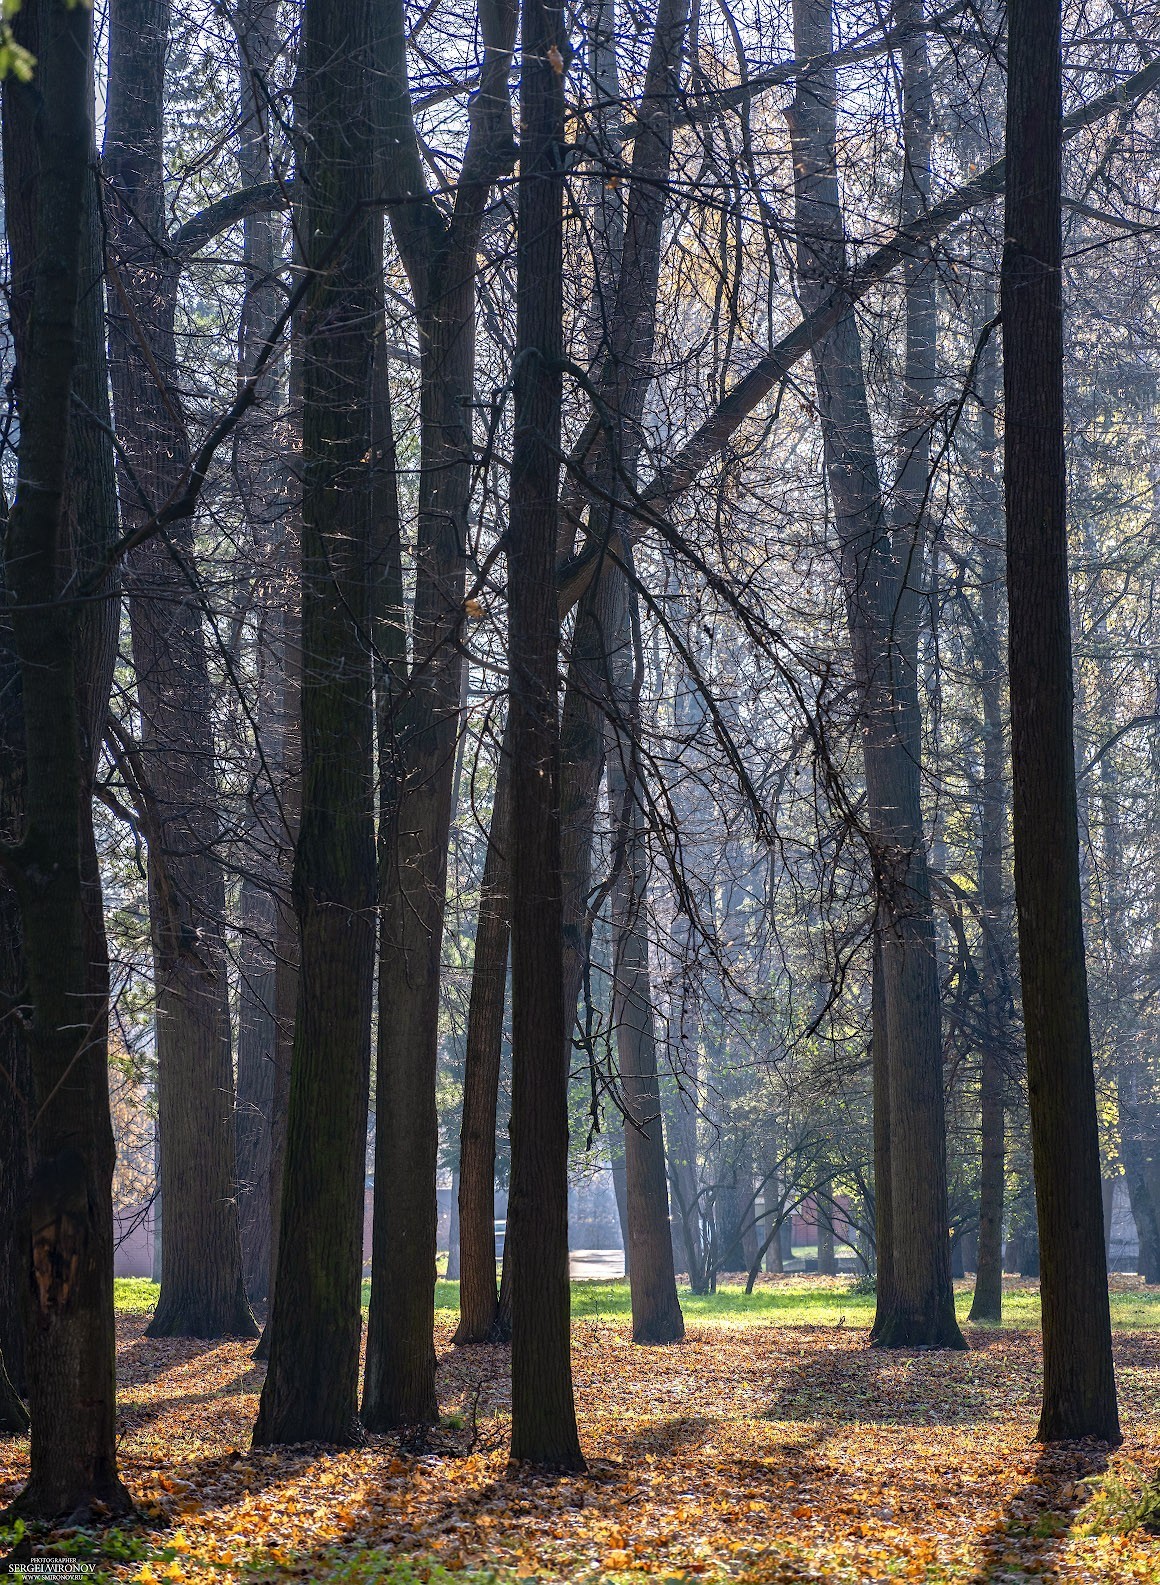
xmin=455 ymin=731 xmax=512 ymax=1342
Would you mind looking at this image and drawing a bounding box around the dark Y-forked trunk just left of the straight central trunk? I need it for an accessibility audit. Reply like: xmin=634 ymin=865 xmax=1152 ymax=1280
xmin=363 ymin=0 xmax=517 ymax=1431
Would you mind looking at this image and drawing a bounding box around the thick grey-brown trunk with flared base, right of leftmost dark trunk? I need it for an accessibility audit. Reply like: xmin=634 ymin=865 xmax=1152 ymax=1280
xmin=105 ymin=0 xmax=257 ymax=1338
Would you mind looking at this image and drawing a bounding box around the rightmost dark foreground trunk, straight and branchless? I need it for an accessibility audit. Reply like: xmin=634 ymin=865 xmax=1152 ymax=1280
xmin=1002 ymin=0 xmax=1120 ymax=1442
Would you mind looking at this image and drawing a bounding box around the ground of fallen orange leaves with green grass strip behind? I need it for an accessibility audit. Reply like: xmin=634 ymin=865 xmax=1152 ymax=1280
xmin=0 ymin=1278 xmax=1160 ymax=1585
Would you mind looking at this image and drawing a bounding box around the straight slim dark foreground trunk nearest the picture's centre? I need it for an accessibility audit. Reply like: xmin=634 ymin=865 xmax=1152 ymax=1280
xmin=507 ymin=0 xmax=585 ymax=1469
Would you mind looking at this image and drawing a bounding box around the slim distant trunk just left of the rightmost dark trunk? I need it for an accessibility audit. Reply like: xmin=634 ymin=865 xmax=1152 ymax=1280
xmin=970 ymin=290 xmax=1009 ymax=1322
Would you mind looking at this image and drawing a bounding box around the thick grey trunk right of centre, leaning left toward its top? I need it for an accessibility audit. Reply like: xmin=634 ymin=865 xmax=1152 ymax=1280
xmin=789 ymin=0 xmax=963 ymax=1349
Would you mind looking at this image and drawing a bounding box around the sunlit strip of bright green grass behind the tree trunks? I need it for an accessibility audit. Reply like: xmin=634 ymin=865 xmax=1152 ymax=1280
xmin=114 ymin=1276 xmax=1160 ymax=1331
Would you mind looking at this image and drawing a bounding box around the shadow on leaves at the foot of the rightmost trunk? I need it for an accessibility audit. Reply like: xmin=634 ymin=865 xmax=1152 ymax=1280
xmin=971 ymin=1441 xmax=1108 ymax=1585
